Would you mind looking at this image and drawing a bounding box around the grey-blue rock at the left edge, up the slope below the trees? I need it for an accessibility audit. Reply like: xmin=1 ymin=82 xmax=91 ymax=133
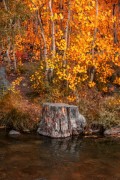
xmin=0 ymin=67 xmax=9 ymax=96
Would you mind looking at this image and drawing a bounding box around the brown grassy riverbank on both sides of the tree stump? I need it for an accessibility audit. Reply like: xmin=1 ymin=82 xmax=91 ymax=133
xmin=0 ymin=93 xmax=120 ymax=135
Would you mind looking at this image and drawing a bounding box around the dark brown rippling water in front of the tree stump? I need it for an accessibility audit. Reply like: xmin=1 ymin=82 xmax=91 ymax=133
xmin=0 ymin=133 xmax=120 ymax=180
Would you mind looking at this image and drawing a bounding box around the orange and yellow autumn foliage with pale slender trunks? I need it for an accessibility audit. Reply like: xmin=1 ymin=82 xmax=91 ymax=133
xmin=0 ymin=0 xmax=120 ymax=102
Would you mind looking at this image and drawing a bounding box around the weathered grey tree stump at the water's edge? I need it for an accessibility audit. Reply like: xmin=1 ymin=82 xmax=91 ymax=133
xmin=37 ymin=103 xmax=86 ymax=138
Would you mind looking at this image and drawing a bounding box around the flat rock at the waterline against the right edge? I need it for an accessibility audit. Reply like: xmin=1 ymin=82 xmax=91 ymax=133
xmin=104 ymin=127 xmax=120 ymax=136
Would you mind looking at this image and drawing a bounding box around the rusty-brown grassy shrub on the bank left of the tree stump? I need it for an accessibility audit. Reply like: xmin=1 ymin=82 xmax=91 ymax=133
xmin=0 ymin=93 xmax=40 ymax=130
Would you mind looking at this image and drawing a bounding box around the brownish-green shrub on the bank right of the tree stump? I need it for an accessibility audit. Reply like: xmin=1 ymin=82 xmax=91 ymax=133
xmin=76 ymin=88 xmax=120 ymax=128
